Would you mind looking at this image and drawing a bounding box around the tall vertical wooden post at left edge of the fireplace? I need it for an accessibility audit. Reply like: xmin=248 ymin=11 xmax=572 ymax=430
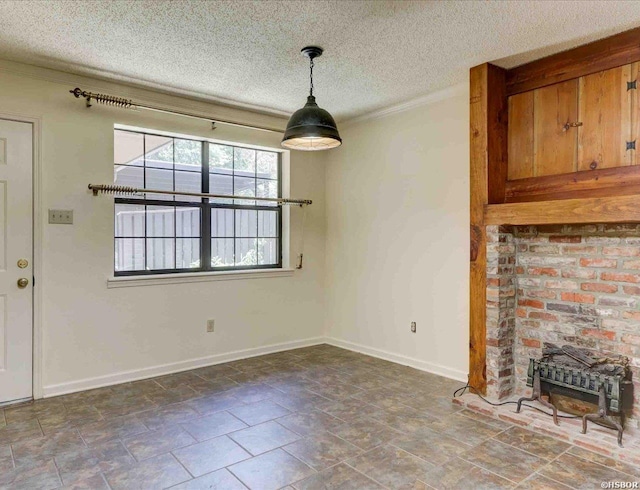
xmin=469 ymin=63 xmax=507 ymax=393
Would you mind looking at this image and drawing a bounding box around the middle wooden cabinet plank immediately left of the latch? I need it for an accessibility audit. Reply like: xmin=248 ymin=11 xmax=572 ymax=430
xmin=534 ymin=80 xmax=578 ymax=177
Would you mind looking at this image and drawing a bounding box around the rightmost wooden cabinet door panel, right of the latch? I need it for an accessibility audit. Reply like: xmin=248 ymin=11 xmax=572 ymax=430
xmin=578 ymin=65 xmax=634 ymax=170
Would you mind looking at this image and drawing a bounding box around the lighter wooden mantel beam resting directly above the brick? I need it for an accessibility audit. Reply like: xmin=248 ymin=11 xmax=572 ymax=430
xmin=484 ymin=195 xmax=640 ymax=225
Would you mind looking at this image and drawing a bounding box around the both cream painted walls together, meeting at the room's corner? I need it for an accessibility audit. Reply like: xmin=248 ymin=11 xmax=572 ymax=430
xmin=0 ymin=56 xmax=469 ymax=395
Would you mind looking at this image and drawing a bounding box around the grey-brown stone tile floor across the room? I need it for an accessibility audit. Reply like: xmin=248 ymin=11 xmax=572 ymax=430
xmin=0 ymin=345 xmax=640 ymax=490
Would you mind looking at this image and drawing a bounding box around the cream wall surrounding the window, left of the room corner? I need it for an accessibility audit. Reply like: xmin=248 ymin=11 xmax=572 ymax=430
xmin=0 ymin=62 xmax=325 ymax=395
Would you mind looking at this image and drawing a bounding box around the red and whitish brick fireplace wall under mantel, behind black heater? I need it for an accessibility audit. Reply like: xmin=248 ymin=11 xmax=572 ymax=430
xmin=486 ymin=224 xmax=640 ymax=425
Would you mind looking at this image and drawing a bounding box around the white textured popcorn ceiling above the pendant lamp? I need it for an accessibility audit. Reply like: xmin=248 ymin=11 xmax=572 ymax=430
xmin=0 ymin=0 xmax=640 ymax=120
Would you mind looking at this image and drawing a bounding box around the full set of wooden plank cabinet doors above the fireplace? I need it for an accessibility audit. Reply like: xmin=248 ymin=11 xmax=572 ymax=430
xmin=507 ymin=63 xmax=640 ymax=180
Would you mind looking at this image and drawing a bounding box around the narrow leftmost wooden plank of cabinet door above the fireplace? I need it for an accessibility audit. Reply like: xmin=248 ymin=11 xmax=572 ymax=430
xmin=507 ymin=91 xmax=534 ymax=180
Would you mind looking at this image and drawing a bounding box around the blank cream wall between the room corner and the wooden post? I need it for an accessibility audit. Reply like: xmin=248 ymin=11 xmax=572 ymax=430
xmin=325 ymin=87 xmax=469 ymax=380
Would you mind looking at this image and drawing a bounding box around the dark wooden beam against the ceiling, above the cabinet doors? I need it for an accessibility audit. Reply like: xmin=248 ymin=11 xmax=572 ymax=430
xmin=506 ymin=27 xmax=640 ymax=95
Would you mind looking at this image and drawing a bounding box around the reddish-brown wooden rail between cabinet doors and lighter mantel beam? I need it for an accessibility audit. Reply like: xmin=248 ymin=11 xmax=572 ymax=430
xmin=505 ymin=166 xmax=640 ymax=203
